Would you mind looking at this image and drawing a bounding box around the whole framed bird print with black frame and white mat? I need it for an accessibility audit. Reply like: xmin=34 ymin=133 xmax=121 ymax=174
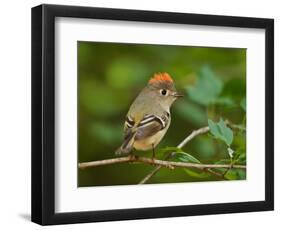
xmin=32 ymin=5 xmax=274 ymax=225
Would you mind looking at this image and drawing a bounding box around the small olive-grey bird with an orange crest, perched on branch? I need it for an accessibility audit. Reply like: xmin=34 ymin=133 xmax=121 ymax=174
xmin=115 ymin=72 xmax=183 ymax=159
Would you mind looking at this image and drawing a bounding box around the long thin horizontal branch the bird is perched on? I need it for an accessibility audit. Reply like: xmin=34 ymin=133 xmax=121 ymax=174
xmin=78 ymin=155 xmax=246 ymax=169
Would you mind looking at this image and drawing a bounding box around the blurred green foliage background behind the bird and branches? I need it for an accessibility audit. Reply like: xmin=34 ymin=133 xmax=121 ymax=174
xmin=78 ymin=41 xmax=246 ymax=186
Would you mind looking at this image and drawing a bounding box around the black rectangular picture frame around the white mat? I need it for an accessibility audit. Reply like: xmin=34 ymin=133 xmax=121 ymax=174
xmin=31 ymin=5 xmax=274 ymax=225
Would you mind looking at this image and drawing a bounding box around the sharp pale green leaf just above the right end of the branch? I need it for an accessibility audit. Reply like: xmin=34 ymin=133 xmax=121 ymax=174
xmin=208 ymin=119 xmax=233 ymax=146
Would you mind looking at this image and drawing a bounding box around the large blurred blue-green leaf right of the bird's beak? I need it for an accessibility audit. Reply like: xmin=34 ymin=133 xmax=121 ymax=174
xmin=187 ymin=66 xmax=223 ymax=105
